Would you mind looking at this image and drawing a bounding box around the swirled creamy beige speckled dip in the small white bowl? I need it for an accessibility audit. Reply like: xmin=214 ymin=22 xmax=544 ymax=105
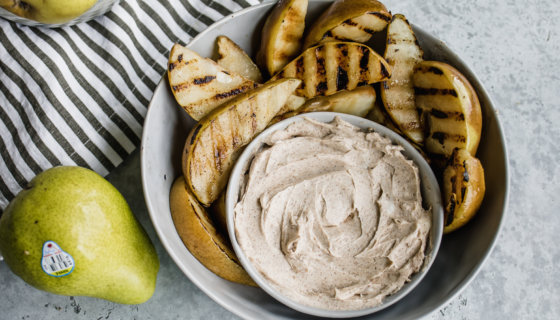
xmin=234 ymin=118 xmax=431 ymax=310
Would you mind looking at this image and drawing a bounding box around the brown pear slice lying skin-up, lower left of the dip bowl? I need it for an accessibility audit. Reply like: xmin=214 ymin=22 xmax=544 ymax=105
xmin=169 ymin=177 xmax=257 ymax=287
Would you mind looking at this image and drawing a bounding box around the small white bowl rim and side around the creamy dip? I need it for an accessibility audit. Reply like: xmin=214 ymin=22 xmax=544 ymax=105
xmin=226 ymin=112 xmax=443 ymax=318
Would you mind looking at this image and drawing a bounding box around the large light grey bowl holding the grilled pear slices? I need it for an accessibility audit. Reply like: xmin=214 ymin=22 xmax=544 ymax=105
xmin=140 ymin=0 xmax=508 ymax=319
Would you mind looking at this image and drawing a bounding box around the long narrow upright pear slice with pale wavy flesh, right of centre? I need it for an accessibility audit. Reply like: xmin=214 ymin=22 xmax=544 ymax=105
xmin=381 ymin=14 xmax=424 ymax=145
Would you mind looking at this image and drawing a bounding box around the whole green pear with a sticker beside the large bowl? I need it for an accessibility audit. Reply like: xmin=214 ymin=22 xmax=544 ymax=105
xmin=0 ymin=167 xmax=159 ymax=304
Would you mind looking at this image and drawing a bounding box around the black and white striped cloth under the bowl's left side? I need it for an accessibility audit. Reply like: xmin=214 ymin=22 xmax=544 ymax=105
xmin=0 ymin=0 xmax=259 ymax=210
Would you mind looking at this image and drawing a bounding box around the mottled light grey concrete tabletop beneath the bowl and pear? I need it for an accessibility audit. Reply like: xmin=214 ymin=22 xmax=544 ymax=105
xmin=0 ymin=0 xmax=560 ymax=320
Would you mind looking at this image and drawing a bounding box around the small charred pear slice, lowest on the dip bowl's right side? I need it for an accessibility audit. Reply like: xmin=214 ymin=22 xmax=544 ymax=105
xmin=443 ymin=149 xmax=486 ymax=233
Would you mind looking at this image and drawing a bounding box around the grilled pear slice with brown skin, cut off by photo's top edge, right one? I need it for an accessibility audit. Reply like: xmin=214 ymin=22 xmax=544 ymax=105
xmin=303 ymin=0 xmax=391 ymax=48
